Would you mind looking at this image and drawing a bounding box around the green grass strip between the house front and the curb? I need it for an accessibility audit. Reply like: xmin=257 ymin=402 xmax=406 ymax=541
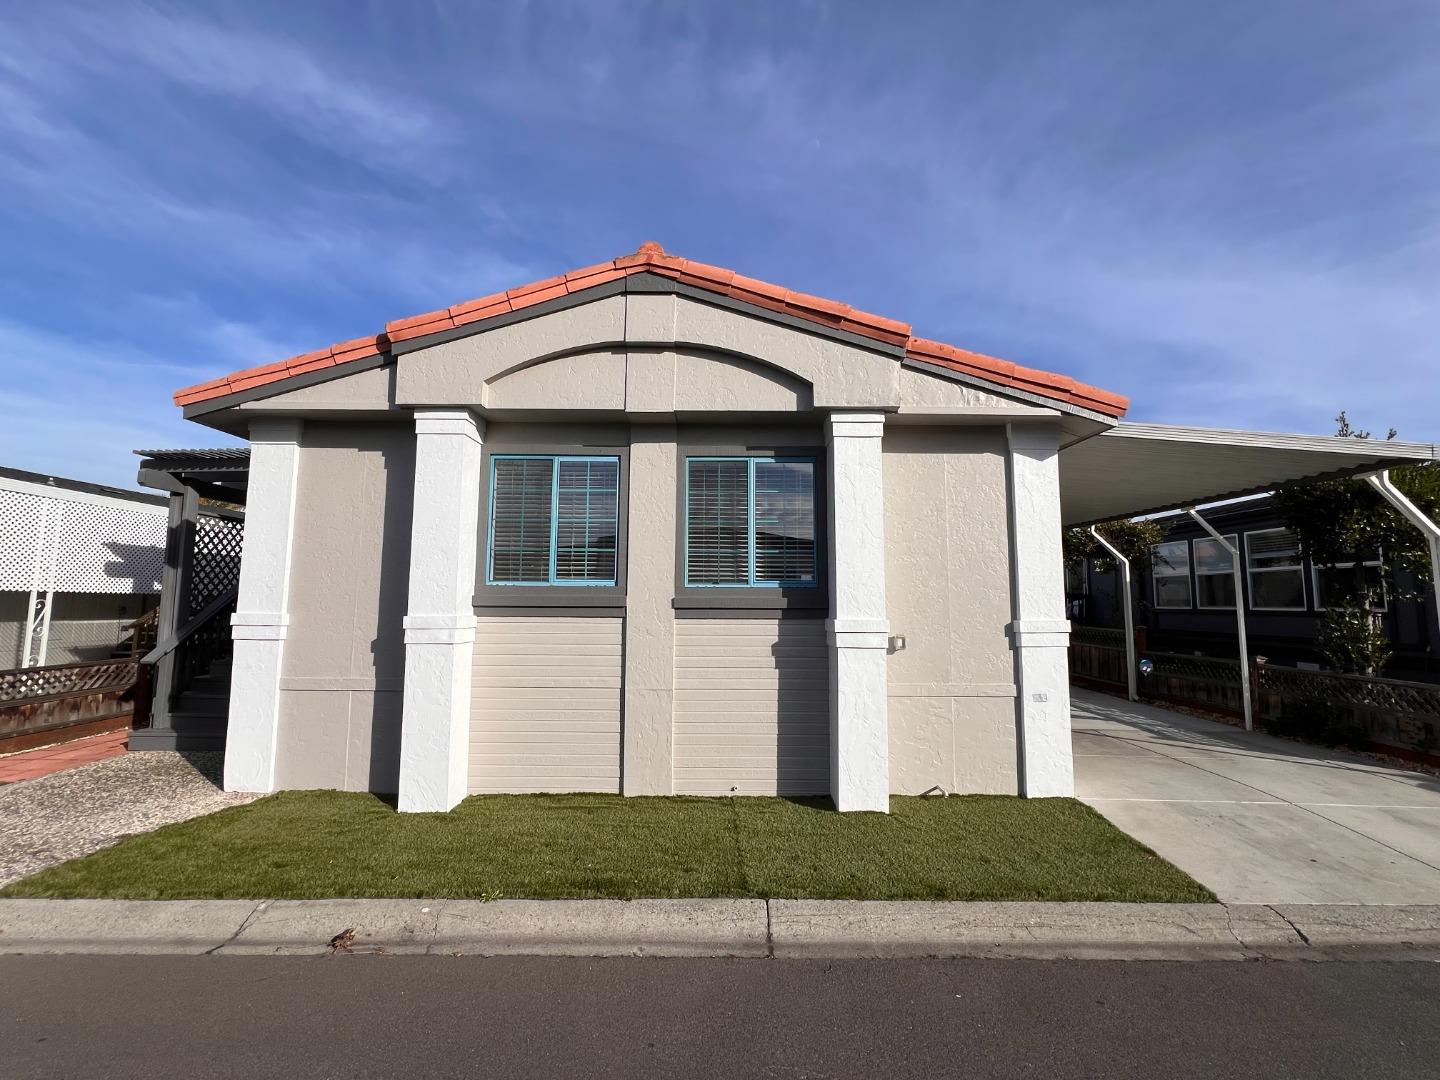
xmin=0 ymin=791 xmax=1214 ymax=901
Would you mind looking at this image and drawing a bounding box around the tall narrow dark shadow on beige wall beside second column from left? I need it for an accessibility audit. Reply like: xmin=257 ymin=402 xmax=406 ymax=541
xmin=369 ymin=429 xmax=415 ymax=793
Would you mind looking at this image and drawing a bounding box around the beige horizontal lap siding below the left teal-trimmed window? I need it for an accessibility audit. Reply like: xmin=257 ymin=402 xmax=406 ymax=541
xmin=469 ymin=616 xmax=624 ymax=795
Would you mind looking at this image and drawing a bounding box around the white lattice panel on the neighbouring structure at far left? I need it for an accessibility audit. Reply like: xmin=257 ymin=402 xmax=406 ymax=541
xmin=0 ymin=490 xmax=166 ymax=593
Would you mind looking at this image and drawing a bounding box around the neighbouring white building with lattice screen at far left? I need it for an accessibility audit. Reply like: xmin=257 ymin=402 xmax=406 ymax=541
xmin=0 ymin=468 xmax=166 ymax=670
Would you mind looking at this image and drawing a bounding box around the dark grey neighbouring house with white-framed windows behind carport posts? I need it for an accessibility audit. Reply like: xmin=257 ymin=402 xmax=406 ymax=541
xmin=1067 ymin=497 xmax=1440 ymax=680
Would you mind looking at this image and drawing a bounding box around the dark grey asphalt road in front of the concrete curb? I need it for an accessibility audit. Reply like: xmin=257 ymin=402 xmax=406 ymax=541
xmin=0 ymin=956 xmax=1440 ymax=1080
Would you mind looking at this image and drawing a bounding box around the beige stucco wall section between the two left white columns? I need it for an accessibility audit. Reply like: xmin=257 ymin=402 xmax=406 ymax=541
xmin=276 ymin=422 xmax=415 ymax=792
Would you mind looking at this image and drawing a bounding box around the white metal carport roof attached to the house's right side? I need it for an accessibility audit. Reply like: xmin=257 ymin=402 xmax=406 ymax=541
xmin=1060 ymin=423 xmax=1437 ymax=526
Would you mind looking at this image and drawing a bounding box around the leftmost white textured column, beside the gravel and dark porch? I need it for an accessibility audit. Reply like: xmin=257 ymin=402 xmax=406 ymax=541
xmin=225 ymin=419 xmax=301 ymax=791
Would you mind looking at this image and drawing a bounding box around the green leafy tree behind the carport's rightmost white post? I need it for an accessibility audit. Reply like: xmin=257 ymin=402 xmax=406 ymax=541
xmin=1274 ymin=412 xmax=1440 ymax=674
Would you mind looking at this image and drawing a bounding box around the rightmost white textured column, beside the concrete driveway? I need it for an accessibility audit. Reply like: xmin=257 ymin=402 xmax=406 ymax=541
xmin=1008 ymin=423 xmax=1076 ymax=798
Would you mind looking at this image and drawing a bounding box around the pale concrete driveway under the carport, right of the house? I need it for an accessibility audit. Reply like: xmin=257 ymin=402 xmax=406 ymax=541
xmin=1071 ymin=688 xmax=1440 ymax=904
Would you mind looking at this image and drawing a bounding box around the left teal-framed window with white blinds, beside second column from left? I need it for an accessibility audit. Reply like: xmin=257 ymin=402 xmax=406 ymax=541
xmin=485 ymin=454 xmax=621 ymax=585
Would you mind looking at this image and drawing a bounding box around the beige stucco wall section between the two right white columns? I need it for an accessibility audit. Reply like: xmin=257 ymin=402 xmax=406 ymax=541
xmin=884 ymin=426 xmax=1018 ymax=795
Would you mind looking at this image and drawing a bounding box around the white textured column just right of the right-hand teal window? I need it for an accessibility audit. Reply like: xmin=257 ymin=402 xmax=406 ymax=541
xmin=825 ymin=412 xmax=890 ymax=812
